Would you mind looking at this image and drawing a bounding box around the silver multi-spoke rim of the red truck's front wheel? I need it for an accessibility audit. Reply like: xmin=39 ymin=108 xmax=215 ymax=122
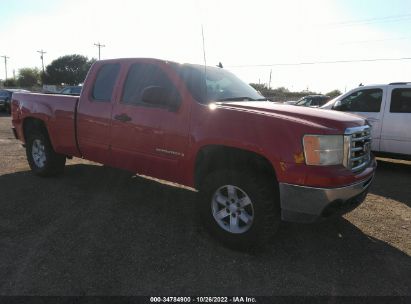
xmin=211 ymin=185 xmax=254 ymax=234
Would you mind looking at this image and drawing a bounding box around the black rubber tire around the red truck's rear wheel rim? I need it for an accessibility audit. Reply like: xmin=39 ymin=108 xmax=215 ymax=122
xmin=26 ymin=129 xmax=66 ymax=177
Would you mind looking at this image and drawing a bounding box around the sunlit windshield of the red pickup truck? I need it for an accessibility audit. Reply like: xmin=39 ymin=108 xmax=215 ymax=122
xmin=177 ymin=64 xmax=266 ymax=104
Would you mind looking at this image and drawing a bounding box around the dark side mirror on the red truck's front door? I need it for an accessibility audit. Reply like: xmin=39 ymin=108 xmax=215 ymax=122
xmin=142 ymin=86 xmax=180 ymax=111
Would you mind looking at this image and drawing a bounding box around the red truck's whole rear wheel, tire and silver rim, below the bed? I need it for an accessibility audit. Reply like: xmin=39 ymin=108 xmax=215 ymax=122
xmin=26 ymin=131 xmax=66 ymax=176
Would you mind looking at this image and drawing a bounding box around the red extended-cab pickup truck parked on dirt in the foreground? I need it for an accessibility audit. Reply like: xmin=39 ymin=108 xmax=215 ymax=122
xmin=12 ymin=59 xmax=376 ymax=247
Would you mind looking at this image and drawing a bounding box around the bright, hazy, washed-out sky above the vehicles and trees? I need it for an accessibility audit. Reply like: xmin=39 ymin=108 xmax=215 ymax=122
xmin=0 ymin=0 xmax=411 ymax=93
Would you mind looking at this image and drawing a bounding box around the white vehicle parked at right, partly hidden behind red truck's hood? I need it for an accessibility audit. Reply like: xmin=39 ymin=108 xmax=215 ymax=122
xmin=321 ymin=82 xmax=411 ymax=159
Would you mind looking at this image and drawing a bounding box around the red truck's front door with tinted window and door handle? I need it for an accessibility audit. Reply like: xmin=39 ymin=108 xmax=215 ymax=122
xmin=111 ymin=60 xmax=190 ymax=182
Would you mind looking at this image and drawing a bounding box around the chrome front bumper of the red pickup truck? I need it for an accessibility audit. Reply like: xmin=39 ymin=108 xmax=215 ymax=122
xmin=280 ymin=174 xmax=374 ymax=223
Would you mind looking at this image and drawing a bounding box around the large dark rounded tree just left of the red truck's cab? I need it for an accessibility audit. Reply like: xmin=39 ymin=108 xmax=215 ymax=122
xmin=42 ymin=54 xmax=96 ymax=85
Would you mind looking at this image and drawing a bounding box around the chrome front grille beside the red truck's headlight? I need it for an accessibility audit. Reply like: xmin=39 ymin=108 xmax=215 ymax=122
xmin=344 ymin=125 xmax=371 ymax=172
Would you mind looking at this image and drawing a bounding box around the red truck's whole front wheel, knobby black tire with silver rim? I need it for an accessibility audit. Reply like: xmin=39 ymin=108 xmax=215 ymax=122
xmin=200 ymin=170 xmax=281 ymax=249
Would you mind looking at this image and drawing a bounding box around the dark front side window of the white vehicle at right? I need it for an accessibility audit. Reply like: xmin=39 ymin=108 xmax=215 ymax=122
xmin=333 ymin=89 xmax=382 ymax=112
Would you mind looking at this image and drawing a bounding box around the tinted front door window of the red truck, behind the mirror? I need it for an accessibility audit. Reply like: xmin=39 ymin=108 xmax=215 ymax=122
xmin=121 ymin=63 xmax=180 ymax=107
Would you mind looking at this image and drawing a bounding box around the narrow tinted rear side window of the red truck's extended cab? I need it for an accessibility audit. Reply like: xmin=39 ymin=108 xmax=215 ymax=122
xmin=92 ymin=63 xmax=120 ymax=102
